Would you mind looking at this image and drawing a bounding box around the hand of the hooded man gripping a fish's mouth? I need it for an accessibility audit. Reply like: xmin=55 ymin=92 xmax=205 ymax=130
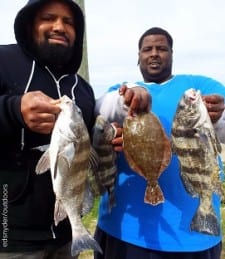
xmin=21 ymin=91 xmax=61 ymax=134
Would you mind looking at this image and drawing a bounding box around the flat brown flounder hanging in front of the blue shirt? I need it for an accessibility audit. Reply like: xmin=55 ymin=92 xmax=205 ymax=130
xmin=123 ymin=112 xmax=171 ymax=205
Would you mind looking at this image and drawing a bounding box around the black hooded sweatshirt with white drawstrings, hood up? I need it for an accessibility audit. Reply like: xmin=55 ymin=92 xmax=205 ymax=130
xmin=0 ymin=0 xmax=95 ymax=251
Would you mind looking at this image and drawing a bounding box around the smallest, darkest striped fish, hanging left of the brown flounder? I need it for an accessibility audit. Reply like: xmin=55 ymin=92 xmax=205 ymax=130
xmin=92 ymin=115 xmax=117 ymax=210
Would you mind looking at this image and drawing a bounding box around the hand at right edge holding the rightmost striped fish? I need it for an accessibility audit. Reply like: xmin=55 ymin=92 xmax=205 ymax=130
xmin=202 ymin=94 xmax=225 ymax=123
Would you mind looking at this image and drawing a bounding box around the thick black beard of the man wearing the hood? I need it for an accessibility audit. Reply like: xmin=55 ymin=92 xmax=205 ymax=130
xmin=33 ymin=42 xmax=73 ymax=70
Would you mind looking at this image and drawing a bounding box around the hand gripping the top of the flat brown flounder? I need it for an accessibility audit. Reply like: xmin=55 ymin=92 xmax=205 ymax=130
xmin=119 ymin=85 xmax=151 ymax=115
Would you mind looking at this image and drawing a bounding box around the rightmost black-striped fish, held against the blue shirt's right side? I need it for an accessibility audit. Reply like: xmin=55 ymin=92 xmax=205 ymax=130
xmin=172 ymin=88 xmax=222 ymax=235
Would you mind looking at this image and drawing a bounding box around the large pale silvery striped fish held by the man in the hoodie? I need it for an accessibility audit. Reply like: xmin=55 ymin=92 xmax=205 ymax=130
xmin=36 ymin=96 xmax=101 ymax=256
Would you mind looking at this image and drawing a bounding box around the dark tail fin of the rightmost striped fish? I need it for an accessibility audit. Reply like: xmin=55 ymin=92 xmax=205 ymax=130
xmin=191 ymin=206 xmax=220 ymax=236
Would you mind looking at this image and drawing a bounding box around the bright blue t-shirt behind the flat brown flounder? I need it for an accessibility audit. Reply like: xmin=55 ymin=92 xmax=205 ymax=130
xmin=98 ymin=75 xmax=225 ymax=251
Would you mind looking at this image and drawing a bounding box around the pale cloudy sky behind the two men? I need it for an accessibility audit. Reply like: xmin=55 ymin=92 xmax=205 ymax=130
xmin=0 ymin=0 xmax=225 ymax=97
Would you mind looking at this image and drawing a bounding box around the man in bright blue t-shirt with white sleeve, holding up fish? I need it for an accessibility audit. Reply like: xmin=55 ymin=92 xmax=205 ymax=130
xmin=95 ymin=27 xmax=225 ymax=259
